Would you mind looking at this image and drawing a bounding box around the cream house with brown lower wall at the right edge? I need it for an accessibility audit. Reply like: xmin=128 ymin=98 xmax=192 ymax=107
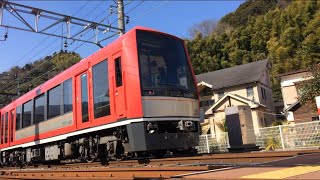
xmin=279 ymin=70 xmax=318 ymax=123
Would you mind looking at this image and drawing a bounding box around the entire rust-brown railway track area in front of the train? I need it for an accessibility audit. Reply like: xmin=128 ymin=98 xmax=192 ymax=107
xmin=0 ymin=150 xmax=319 ymax=179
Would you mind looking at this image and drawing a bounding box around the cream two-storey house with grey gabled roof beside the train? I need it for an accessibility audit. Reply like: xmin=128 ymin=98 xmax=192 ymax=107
xmin=196 ymin=60 xmax=274 ymax=134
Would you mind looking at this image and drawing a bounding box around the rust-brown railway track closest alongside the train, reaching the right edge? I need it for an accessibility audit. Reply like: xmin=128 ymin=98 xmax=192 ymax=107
xmin=47 ymin=150 xmax=319 ymax=169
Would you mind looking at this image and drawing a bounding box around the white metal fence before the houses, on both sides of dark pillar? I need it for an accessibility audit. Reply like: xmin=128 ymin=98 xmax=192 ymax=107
xmin=197 ymin=121 xmax=320 ymax=153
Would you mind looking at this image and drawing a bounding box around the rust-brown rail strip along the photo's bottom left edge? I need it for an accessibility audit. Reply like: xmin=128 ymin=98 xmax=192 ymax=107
xmin=1 ymin=166 xmax=215 ymax=179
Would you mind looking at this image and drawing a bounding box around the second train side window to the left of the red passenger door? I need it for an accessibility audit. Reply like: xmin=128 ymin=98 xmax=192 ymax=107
xmin=48 ymin=85 xmax=61 ymax=119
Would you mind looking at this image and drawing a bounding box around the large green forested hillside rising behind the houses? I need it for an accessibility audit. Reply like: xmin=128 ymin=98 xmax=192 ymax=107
xmin=187 ymin=0 xmax=320 ymax=99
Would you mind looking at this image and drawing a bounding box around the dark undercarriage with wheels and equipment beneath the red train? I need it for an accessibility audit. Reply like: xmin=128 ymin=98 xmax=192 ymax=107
xmin=1 ymin=120 xmax=199 ymax=166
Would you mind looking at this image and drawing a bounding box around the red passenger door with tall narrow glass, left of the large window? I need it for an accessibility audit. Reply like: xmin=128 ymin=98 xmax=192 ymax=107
xmin=76 ymin=71 xmax=90 ymax=129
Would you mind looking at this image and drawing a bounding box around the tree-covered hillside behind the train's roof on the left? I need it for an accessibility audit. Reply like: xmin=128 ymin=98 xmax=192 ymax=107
xmin=0 ymin=51 xmax=81 ymax=107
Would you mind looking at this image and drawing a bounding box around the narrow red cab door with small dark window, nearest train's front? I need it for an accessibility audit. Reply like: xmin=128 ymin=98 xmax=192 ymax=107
xmin=113 ymin=52 xmax=126 ymax=119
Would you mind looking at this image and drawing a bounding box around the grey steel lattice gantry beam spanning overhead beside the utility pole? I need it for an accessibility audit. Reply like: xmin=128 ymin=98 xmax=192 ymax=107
xmin=0 ymin=0 xmax=123 ymax=45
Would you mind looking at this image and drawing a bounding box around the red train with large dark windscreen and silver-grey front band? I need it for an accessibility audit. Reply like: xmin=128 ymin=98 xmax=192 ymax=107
xmin=0 ymin=27 xmax=199 ymax=165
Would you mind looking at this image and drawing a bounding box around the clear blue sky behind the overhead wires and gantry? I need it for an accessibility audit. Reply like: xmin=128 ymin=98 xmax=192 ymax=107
xmin=0 ymin=0 xmax=244 ymax=73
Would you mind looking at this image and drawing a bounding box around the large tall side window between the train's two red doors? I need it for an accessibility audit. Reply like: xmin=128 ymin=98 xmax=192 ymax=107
xmin=92 ymin=60 xmax=110 ymax=118
